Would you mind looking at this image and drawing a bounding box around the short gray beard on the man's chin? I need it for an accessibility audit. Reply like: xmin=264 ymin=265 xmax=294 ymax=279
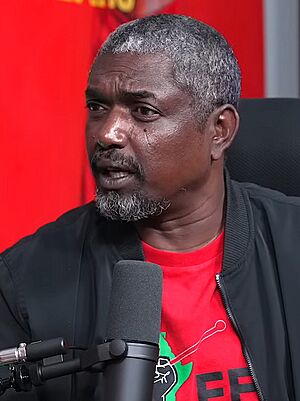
xmin=96 ymin=189 xmax=170 ymax=221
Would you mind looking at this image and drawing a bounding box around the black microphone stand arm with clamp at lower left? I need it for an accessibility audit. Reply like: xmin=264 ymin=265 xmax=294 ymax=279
xmin=0 ymin=339 xmax=159 ymax=401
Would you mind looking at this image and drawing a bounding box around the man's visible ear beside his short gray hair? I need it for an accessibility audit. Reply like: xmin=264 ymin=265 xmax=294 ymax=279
xmin=210 ymin=104 xmax=240 ymax=160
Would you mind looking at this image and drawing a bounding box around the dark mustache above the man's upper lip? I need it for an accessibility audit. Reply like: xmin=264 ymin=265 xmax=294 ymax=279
xmin=90 ymin=149 xmax=144 ymax=180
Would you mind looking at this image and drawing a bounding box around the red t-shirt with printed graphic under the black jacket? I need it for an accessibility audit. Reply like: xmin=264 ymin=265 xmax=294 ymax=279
xmin=143 ymin=233 xmax=258 ymax=401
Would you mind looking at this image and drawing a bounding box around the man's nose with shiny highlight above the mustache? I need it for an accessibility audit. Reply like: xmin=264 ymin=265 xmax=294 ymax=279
xmin=96 ymin=112 xmax=129 ymax=149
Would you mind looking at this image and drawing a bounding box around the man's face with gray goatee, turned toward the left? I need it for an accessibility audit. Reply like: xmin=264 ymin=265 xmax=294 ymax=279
xmin=86 ymin=54 xmax=211 ymax=220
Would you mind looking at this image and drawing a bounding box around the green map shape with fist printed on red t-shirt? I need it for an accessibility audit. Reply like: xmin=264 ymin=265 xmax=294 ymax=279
xmin=154 ymin=333 xmax=193 ymax=401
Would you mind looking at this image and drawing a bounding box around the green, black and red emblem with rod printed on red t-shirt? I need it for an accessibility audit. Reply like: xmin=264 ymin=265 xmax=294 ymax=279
xmin=153 ymin=320 xmax=226 ymax=401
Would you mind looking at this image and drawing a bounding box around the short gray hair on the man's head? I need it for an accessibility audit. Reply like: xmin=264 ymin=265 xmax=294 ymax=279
xmin=99 ymin=14 xmax=241 ymax=124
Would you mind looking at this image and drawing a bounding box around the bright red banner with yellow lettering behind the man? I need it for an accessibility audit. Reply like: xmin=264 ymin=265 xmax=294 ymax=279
xmin=0 ymin=0 xmax=264 ymax=250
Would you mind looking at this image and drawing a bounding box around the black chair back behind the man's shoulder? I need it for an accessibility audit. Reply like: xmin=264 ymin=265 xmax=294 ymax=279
xmin=226 ymin=98 xmax=300 ymax=196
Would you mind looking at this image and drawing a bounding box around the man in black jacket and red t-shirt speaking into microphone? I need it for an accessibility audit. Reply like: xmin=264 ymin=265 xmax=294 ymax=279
xmin=0 ymin=15 xmax=300 ymax=401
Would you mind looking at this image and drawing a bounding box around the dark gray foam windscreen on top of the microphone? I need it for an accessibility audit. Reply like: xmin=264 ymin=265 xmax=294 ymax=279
xmin=106 ymin=260 xmax=162 ymax=344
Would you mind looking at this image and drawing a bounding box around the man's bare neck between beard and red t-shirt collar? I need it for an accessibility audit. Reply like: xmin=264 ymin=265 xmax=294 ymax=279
xmin=136 ymin=178 xmax=225 ymax=252
